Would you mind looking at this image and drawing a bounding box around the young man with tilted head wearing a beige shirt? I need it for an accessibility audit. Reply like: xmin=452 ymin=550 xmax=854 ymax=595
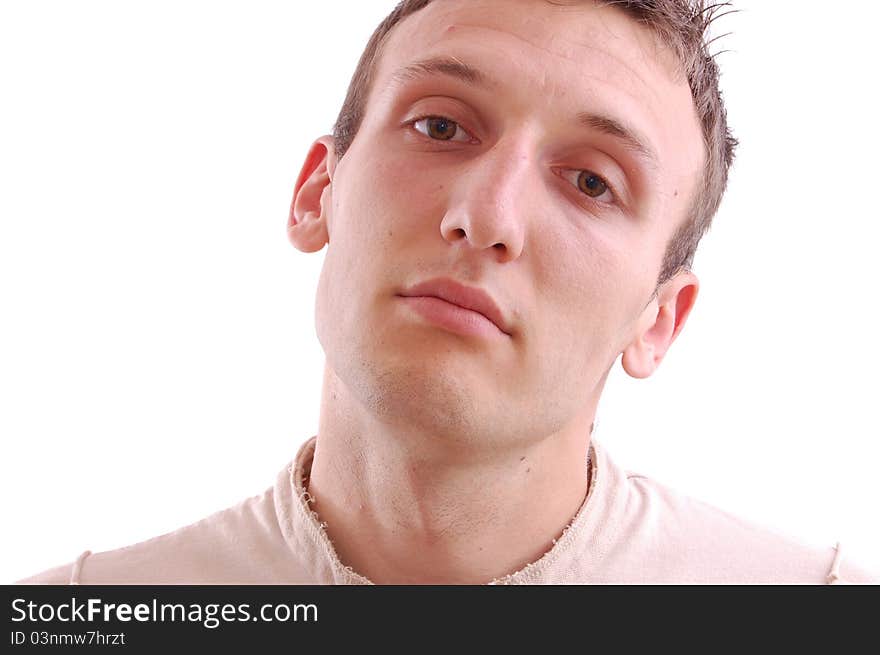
xmin=22 ymin=0 xmax=869 ymax=584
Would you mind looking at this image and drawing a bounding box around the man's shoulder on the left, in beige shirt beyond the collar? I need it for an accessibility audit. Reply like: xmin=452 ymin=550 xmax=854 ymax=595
xmin=18 ymin=488 xmax=308 ymax=584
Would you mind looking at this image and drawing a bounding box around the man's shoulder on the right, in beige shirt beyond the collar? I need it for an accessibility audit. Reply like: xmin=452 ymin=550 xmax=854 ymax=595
xmin=623 ymin=472 xmax=877 ymax=584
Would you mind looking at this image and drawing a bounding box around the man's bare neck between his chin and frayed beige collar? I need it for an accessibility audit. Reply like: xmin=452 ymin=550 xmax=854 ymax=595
xmin=308 ymin=372 xmax=594 ymax=584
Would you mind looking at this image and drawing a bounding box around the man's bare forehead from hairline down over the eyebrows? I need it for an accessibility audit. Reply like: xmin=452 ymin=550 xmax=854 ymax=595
xmin=367 ymin=0 xmax=704 ymax=197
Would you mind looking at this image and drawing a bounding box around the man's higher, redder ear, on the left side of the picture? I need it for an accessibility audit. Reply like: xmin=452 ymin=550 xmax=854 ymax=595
xmin=287 ymin=136 xmax=336 ymax=252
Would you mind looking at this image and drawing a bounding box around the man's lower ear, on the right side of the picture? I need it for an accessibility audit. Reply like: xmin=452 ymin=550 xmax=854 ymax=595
xmin=622 ymin=271 xmax=700 ymax=378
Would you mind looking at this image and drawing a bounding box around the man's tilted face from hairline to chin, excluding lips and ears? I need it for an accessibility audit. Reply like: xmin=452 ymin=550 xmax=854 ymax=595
xmin=316 ymin=0 xmax=704 ymax=454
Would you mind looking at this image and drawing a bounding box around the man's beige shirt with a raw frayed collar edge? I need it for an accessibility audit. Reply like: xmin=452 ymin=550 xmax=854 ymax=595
xmin=18 ymin=437 xmax=880 ymax=584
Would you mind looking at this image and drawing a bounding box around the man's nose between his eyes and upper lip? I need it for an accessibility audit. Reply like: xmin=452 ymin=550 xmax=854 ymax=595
xmin=440 ymin=142 xmax=534 ymax=262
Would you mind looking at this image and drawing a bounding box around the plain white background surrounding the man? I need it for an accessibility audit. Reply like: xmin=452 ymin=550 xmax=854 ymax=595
xmin=0 ymin=0 xmax=880 ymax=581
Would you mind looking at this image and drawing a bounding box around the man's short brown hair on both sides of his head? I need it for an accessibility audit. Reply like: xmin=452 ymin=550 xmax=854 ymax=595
xmin=333 ymin=0 xmax=737 ymax=286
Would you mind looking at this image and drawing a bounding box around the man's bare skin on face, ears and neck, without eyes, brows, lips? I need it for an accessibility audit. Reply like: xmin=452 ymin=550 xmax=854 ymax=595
xmin=288 ymin=0 xmax=705 ymax=584
